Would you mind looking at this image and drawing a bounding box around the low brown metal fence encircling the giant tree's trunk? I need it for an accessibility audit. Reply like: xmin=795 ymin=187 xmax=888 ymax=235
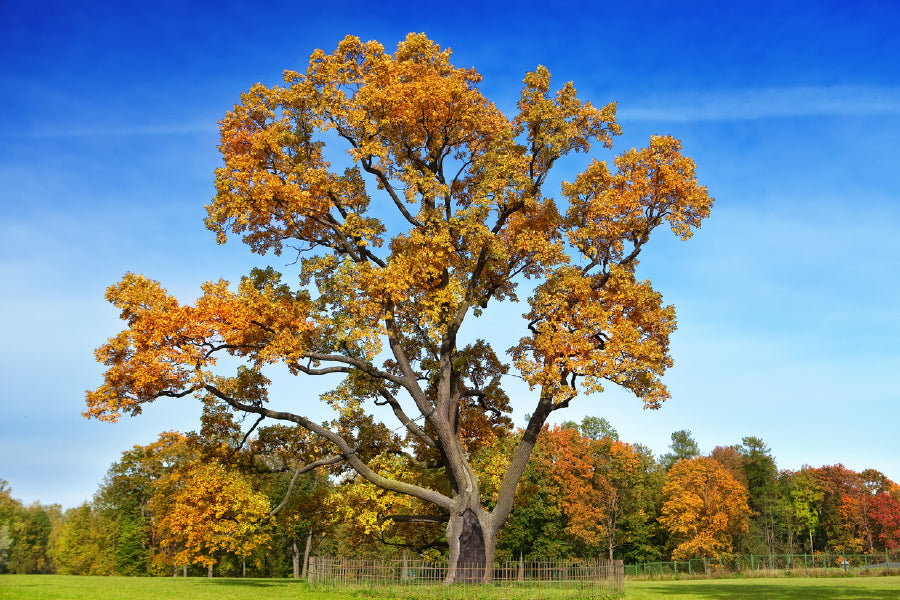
xmin=307 ymin=556 xmax=625 ymax=600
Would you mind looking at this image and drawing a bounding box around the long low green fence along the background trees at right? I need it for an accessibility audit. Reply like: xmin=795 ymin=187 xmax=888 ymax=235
xmin=624 ymin=552 xmax=900 ymax=578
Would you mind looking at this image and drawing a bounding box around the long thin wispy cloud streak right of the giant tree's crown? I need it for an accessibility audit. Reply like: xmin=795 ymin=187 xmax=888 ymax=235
xmin=617 ymin=86 xmax=900 ymax=122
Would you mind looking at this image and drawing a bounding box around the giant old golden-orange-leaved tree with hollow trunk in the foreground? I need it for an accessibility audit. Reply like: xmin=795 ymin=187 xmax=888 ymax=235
xmin=86 ymin=34 xmax=712 ymax=581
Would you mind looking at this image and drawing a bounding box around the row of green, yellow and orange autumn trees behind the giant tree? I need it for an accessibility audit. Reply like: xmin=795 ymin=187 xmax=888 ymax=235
xmin=0 ymin=418 xmax=900 ymax=577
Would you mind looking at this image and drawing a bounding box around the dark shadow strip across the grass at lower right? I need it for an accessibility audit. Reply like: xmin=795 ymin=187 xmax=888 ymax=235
xmin=644 ymin=582 xmax=898 ymax=600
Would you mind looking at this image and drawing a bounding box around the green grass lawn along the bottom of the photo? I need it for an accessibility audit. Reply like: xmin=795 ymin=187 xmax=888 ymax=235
xmin=0 ymin=575 xmax=900 ymax=600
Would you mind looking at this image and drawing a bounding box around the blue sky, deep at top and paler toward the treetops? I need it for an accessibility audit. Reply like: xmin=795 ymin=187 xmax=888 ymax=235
xmin=0 ymin=0 xmax=900 ymax=507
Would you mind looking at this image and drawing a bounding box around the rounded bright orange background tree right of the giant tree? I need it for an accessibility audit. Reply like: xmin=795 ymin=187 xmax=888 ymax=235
xmin=660 ymin=457 xmax=750 ymax=560
